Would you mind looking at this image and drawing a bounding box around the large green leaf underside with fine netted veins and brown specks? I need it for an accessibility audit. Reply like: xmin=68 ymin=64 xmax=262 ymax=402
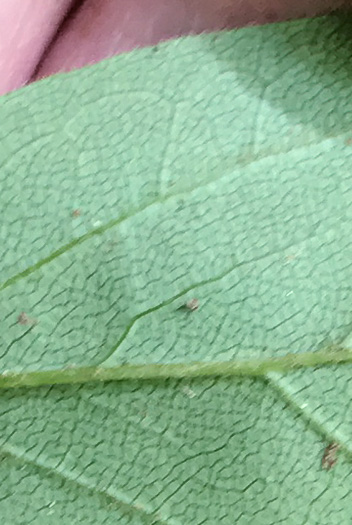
xmin=0 ymin=13 xmax=352 ymax=525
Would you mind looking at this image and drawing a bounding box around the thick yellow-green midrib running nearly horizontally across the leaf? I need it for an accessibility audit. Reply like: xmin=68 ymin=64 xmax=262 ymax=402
xmin=0 ymin=348 xmax=352 ymax=388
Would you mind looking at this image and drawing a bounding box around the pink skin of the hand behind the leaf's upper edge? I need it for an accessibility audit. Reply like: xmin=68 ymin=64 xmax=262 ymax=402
xmin=0 ymin=0 xmax=352 ymax=94
